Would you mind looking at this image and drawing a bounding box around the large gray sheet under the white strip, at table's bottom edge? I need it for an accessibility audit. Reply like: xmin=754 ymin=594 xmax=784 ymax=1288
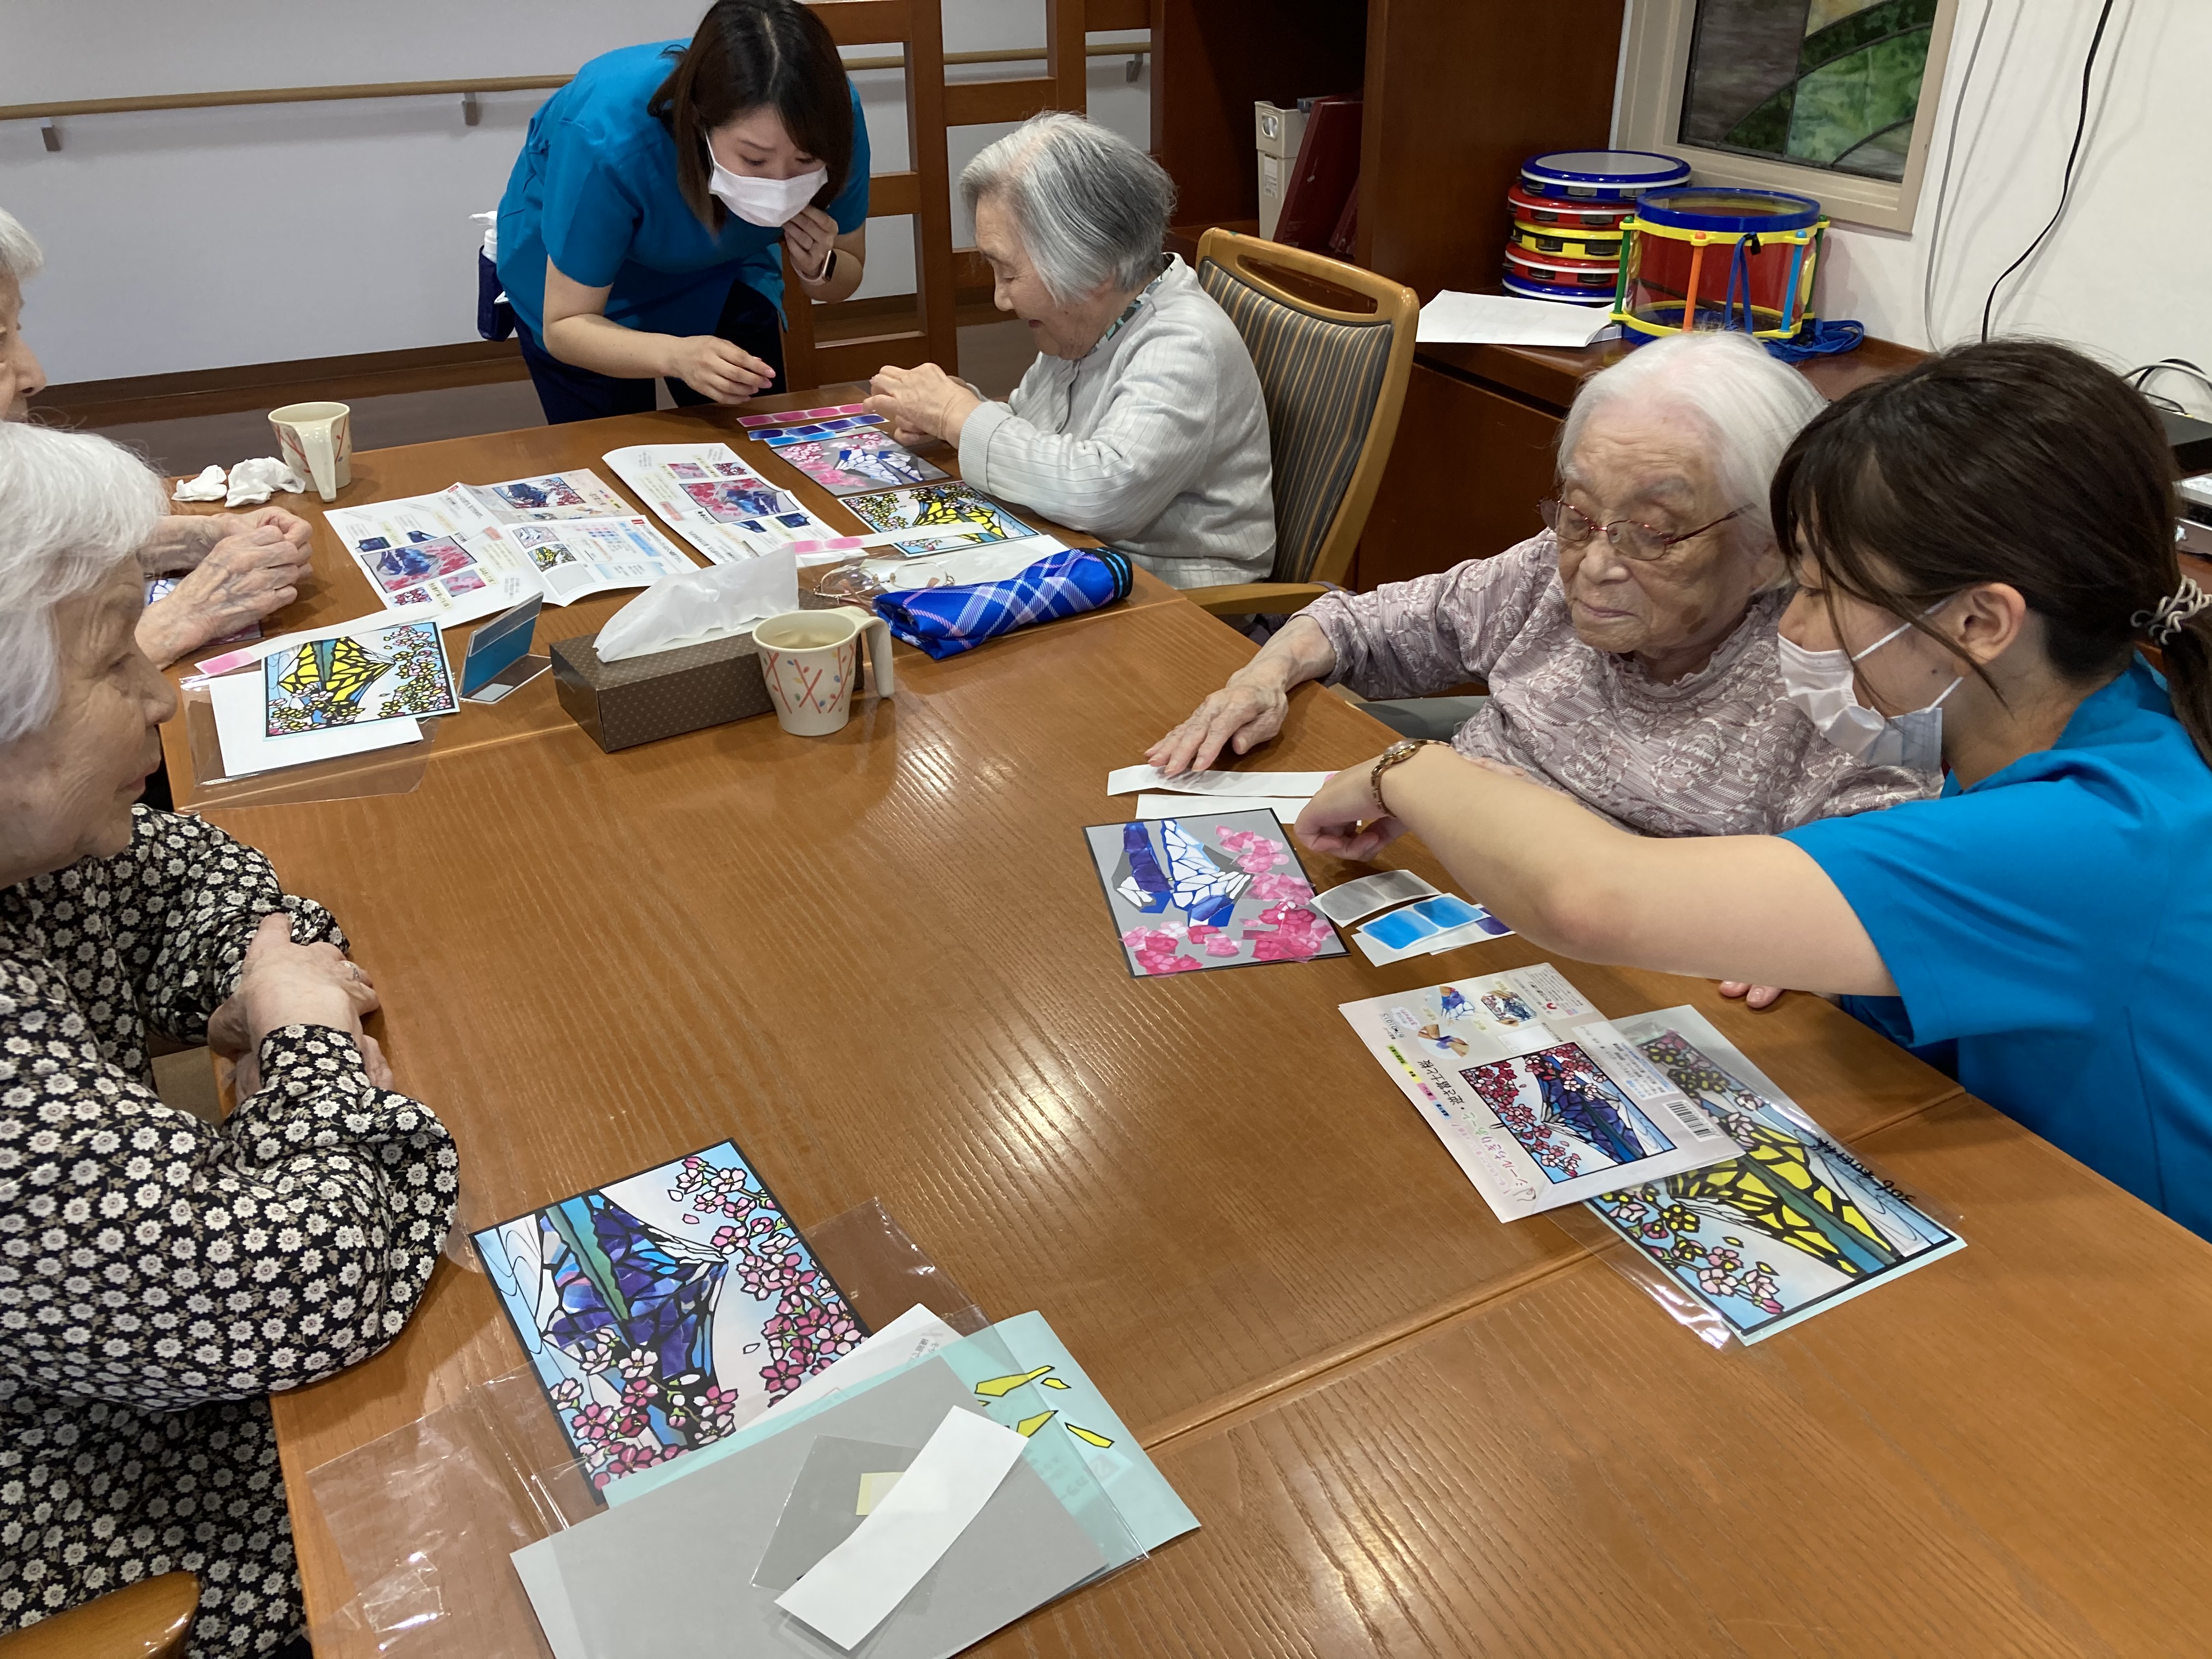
xmin=535 ymin=1358 xmax=1137 ymax=1659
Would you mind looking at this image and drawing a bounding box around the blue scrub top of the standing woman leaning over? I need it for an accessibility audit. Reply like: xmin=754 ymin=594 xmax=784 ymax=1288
xmin=500 ymin=40 xmax=867 ymax=338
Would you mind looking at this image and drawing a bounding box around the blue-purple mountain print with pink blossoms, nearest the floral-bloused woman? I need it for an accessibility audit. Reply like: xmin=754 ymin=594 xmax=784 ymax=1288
xmin=473 ymin=1142 xmax=867 ymax=1487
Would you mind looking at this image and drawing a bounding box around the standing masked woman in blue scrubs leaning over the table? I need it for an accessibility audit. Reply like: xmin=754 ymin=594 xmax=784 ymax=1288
xmin=500 ymin=0 xmax=867 ymax=425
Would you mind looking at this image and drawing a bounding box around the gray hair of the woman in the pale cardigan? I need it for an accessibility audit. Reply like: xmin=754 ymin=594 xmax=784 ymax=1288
xmin=960 ymin=111 xmax=1175 ymax=305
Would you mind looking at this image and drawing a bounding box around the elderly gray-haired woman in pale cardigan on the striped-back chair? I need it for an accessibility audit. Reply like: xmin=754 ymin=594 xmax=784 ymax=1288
xmin=870 ymin=115 xmax=1274 ymax=589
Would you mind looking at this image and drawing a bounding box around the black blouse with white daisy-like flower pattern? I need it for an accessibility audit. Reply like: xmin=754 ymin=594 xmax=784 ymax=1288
xmin=0 ymin=808 xmax=456 ymax=1657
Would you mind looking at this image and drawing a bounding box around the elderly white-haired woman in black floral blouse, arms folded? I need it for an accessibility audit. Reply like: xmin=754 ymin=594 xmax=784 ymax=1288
xmin=0 ymin=425 xmax=456 ymax=1655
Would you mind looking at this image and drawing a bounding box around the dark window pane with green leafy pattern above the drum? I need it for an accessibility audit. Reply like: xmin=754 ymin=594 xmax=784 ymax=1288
xmin=1679 ymin=0 xmax=1938 ymax=179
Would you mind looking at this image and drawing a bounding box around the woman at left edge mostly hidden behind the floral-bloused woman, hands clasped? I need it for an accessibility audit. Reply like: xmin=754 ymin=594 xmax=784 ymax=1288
xmin=0 ymin=210 xmax=312 ymax=668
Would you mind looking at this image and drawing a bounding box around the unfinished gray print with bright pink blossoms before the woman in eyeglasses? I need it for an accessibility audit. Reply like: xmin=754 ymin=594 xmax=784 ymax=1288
xmin=1084 ymin=810 xmax=1345 ymax=980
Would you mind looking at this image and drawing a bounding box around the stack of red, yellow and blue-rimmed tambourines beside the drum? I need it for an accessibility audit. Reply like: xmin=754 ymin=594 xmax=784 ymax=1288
xmin=1504 ymin=150 xmax=1690 ymax=307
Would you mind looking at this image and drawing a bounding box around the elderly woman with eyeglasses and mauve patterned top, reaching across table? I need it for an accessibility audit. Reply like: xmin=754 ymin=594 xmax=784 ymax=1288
xmin=1148 ymin=334 xmax=1942 ymax=836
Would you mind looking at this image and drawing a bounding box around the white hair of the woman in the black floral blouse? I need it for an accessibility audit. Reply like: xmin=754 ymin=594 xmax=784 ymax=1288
xmin=0 ymin=420 xmax=161 ymax=748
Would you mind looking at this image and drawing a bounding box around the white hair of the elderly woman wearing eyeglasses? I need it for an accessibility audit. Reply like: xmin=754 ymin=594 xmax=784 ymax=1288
xmin=1560 ymin=330 xmax=1827 ymax=544
